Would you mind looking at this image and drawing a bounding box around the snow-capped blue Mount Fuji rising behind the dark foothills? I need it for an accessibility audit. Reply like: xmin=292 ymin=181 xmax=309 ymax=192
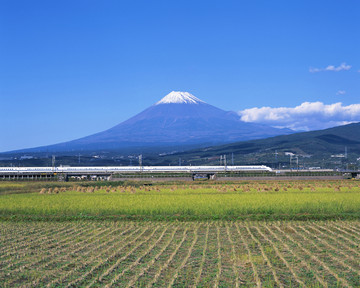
xmin=10 ymin=91 xmax=293 ymax=152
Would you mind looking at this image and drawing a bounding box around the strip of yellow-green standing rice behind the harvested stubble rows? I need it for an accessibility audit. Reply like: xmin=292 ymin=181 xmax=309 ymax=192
xmin=0 ymin=181 xmax=360 ymax=220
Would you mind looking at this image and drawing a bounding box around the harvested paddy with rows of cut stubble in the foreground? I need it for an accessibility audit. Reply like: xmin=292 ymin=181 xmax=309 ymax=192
xmin=0 ymin=221 xmax=360 ymax=287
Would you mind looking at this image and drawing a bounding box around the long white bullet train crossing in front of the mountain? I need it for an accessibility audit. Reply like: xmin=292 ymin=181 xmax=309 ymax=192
xmin=0 ymin=165 xmax=272 ymax=175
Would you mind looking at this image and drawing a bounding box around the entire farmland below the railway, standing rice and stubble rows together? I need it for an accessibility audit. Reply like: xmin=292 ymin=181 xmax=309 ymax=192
xmin=0 ymin=180 xmax=360 ymax=287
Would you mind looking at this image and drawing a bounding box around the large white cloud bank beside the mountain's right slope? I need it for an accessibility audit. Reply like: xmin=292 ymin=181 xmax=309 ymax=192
xmin=238 ymin=102 xmax=360 ymax=131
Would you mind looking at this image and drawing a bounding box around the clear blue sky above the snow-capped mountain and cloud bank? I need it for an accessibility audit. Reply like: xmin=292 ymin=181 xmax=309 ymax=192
xmin=0 ymin=0 xmax=360 ymax=151
